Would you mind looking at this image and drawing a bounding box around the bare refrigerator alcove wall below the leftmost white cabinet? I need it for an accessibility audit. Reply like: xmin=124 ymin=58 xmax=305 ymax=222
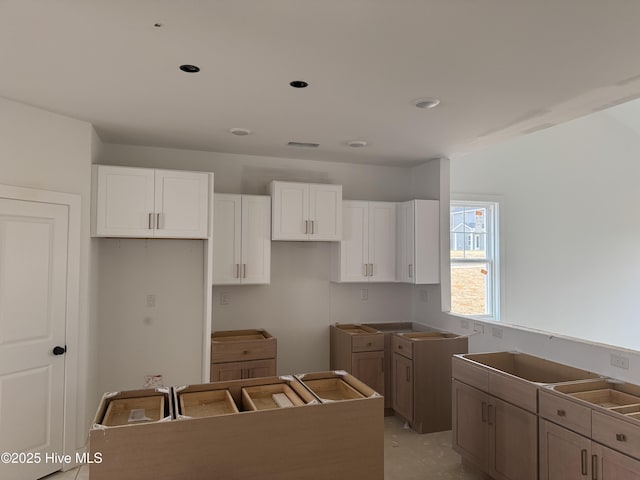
xmin=98 ymin=238 xmax=204 ymax=392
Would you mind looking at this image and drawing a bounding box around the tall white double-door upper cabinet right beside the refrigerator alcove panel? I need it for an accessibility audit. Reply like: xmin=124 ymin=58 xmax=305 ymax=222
xmin=213 ymin=193 xmax=271 ymax=285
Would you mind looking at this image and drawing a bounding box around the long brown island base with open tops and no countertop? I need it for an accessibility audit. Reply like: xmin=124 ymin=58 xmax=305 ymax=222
xmin=89 ymin=372 xmax=384 ymax=480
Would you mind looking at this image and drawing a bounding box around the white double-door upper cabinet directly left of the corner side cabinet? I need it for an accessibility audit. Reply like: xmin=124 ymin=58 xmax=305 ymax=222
xmin=332 ymin=201 xmax=396 ymax=282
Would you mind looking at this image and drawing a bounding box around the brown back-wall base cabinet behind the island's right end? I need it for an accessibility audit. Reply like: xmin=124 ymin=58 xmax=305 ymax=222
xmin=329 ymin=323 xmax=385 ymax=395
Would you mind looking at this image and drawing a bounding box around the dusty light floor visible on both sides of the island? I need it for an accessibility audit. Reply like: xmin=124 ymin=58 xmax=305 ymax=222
xmin=43 ymin=417 xmax=483 ymax=480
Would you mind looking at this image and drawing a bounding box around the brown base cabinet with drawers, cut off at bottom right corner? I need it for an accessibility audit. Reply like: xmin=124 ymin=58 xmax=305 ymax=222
xmin=539 ymin=379 xmax=640 ymax=480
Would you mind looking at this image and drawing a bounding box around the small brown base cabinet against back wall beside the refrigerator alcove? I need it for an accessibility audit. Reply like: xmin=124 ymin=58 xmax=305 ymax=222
xmin=211 ymin=330 xmax=277 ymax=382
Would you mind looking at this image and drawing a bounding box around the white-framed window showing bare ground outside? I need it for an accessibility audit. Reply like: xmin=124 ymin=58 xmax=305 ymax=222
xmin=449 ymin=200 xmax=500 ymax=320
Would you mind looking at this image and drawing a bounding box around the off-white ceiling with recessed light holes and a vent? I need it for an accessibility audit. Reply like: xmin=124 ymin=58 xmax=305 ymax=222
xmin=0 ymin=0 xmax=640 ymax=165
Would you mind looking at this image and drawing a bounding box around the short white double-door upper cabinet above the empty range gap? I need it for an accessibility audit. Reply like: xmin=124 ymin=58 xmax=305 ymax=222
xmin=271 ymin=181 xmax=342 ymax=241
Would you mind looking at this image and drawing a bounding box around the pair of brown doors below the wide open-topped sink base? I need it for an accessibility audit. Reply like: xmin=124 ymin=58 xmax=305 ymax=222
xmin=453 ymin=380 xmax=538 ymax=480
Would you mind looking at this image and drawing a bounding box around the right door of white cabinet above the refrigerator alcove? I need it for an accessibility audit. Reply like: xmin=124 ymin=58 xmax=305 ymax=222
xmin=154 ymin=170 xmax=209 ymax=238
